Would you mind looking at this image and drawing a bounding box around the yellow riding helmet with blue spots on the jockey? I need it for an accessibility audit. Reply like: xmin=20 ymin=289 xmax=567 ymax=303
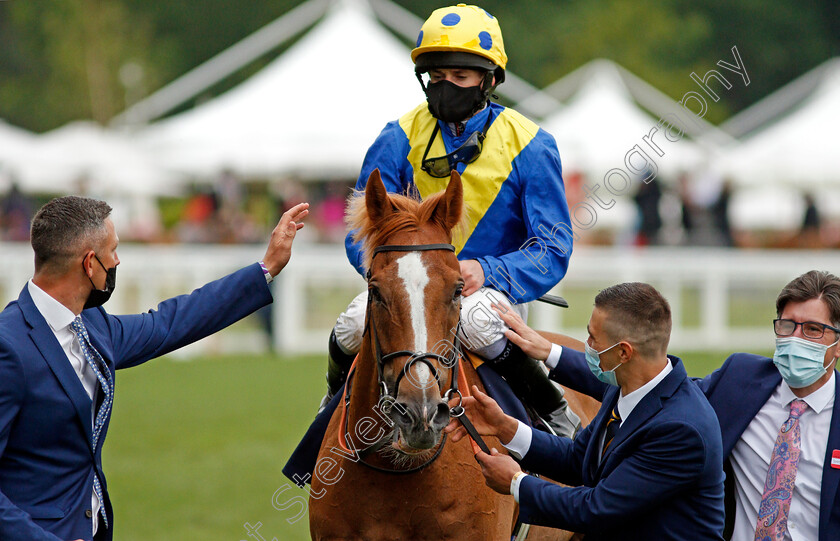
xmin=411 ymin=4 xmax=507 ymax=84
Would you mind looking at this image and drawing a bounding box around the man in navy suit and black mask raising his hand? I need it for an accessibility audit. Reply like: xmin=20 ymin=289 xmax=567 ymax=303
xmin=0 ymin=196 xmax=308 ymax=541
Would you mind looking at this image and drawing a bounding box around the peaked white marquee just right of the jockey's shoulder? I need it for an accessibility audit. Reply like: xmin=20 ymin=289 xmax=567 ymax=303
xmin=542 ymin=59 xmax=728 ymax=228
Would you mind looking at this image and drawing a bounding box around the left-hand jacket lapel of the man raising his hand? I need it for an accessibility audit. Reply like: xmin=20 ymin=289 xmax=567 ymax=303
xmin=18 ymin=286 xmax=93 ymax=453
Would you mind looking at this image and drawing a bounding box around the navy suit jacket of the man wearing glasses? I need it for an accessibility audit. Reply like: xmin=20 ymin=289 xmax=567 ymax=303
xmin=697 ymin=353 xmax=840 ymax=541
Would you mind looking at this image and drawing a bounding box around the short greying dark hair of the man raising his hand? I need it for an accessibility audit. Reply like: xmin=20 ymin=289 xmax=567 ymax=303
xmin=31 ymin=195 xmax=111 ymax=272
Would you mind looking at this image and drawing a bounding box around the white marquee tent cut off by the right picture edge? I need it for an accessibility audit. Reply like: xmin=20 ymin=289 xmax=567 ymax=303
xmin=719 ymin=58 xmax=840 ymax=229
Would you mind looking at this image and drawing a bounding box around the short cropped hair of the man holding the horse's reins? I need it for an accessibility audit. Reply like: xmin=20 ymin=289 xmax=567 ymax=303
xmin=595 ymin=282 xmax=671 ymax=356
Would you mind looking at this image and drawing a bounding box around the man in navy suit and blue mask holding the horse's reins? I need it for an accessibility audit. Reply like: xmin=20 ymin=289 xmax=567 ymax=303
xmin=446 ymin=283 xmax=724 ymax=541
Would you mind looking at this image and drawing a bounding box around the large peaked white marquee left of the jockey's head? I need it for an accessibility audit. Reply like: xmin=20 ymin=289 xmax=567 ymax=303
xmin=141 ymin=0 xmax=424 ymax=178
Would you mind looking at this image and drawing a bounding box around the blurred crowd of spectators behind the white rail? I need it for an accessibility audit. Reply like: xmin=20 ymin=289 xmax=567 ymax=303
xmin=0 ymin=165 xmax=828 ymax=249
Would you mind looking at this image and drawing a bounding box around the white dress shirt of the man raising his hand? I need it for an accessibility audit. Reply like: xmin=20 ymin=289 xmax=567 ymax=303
xmin=27 ymin=280 xmax=100 ymax=535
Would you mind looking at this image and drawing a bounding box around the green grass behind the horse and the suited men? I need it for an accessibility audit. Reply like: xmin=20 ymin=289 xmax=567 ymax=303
xmin=103 ymin=352 xmax=764 ymax=541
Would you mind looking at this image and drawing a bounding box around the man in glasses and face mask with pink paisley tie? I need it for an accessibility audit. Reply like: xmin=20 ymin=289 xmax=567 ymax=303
xmin=540 ymin=271 xmax=840 ymax=541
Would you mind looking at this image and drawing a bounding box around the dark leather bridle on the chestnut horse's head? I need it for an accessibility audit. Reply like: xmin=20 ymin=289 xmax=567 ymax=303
xmin=340 ymin=244 xmax=465 ymax=474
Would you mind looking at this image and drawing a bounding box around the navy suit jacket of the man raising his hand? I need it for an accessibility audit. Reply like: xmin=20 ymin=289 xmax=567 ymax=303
xmin=0 ymin=264 xmax=272 ymax=541
